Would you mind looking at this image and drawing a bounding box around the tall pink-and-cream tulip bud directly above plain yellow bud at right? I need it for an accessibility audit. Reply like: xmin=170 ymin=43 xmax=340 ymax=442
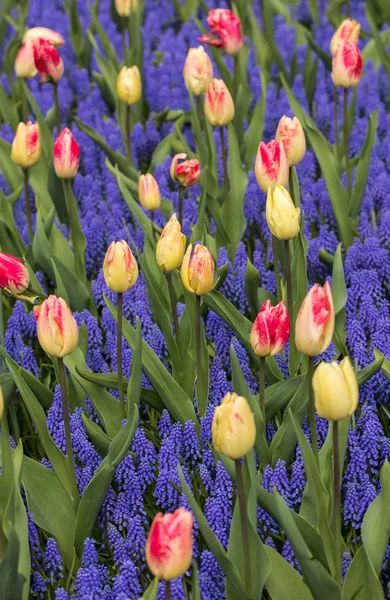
xmin=295 ymin=282 xmax=335 ymax=356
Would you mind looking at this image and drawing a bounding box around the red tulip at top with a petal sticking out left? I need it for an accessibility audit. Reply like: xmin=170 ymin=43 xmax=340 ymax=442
xmin=198 ymin=8 xmax=243 ymax=56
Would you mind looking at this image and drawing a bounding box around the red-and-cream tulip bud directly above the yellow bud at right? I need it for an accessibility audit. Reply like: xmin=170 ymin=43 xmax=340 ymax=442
xmin=255 ymin=140 xmax=288 ymax=192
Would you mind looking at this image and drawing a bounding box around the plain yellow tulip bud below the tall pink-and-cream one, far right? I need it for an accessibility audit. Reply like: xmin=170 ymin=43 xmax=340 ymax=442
xmin=313 ymin=356 xmax=359 ymax=421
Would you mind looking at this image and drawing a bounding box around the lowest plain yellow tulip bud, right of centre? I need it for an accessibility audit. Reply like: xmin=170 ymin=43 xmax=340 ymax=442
xmin=211 ymin=392 xmax=256 ymax=459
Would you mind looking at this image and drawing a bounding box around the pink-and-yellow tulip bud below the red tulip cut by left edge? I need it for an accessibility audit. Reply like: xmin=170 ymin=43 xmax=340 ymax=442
xmin=34 ymin=296 xmax=79 ymax=358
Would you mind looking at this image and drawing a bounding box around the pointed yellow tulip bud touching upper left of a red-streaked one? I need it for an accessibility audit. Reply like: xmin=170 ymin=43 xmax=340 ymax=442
xmin=156 ymin=213 xmax=186 ymax=273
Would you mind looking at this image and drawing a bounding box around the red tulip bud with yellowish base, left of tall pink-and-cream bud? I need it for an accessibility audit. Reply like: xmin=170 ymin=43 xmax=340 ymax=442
xmin=250 ymin=300 xmax=290 ymax=356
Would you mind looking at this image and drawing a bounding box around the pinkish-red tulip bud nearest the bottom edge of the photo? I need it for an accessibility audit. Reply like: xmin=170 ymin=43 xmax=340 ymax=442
xmin=146 ymin=508 xmax=194 ymax=581
